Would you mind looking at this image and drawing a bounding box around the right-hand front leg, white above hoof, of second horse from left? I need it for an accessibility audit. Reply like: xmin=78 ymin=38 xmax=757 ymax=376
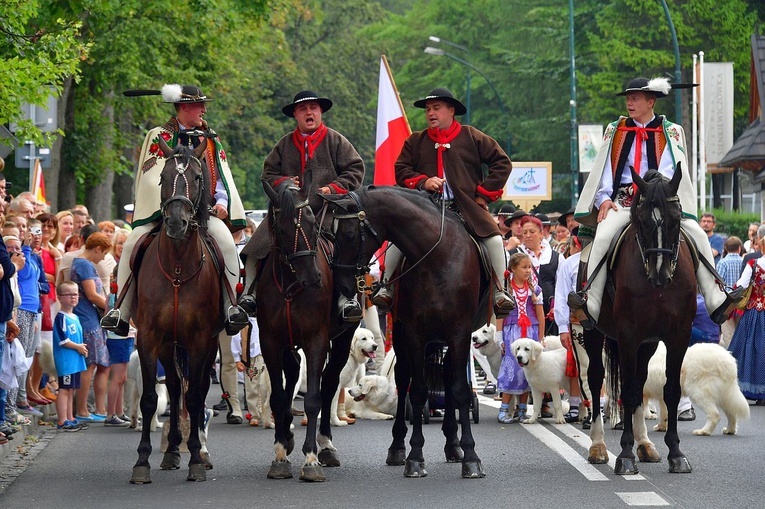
xmin=300 ymin=335 xmax=327 ymax=482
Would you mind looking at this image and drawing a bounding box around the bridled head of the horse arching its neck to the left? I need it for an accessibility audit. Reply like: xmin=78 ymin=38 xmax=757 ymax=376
xmin=322 ymin=191 xmax=382 ymax=298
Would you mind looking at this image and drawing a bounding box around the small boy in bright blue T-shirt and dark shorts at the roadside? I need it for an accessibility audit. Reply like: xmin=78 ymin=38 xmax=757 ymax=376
xmin=53 ymin=281 xmax=88 ymax=431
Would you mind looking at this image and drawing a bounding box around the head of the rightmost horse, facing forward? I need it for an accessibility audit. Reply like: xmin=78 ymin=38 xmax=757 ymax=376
xmin=630 ymin=163 xmax=683 ymax=287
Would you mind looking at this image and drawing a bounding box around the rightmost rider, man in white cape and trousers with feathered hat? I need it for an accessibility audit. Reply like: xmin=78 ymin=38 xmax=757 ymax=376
xmin=568 ymin=78 xmax=742 ymax=328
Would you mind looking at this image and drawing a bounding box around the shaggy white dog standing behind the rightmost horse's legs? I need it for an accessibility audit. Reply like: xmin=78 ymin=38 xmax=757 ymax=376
xmin=643 ymin=341 xmax=749 ymax=436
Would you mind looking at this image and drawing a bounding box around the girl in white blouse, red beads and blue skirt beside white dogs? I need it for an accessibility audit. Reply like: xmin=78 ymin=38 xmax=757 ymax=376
xmin=497 ymin=253 xmax=545 ymax=424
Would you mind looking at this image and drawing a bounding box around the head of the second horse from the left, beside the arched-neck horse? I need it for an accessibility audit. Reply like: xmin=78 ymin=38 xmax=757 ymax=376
xmin=263 ymin=180 xmax=321 ymax=288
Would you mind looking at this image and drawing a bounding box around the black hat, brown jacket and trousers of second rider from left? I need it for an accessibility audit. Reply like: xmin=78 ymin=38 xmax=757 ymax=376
xmin=242 ymin=90 xmax=364 ymax=321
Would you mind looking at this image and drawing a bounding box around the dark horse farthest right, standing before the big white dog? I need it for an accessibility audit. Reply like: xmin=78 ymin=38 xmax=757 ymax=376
xmin=585 ymin=165 xmax=696 ymax=474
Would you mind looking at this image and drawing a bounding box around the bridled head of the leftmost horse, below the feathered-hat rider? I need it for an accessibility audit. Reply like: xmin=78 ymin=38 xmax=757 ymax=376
xmin=159 ymin=136 xmax=210 ymax=240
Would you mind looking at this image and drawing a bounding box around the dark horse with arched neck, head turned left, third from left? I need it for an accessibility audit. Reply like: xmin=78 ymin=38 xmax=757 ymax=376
xmin=325 ymin=187 xmax=490 ymax=478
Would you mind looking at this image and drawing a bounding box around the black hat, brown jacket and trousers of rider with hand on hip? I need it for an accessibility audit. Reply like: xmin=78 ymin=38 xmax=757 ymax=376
xmin=373 ymin=88 xmax=515 ymax=317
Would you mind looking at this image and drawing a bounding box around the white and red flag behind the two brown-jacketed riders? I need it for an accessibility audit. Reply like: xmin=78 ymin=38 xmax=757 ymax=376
xmin=374 ymin=55 xmax=412 ymax=186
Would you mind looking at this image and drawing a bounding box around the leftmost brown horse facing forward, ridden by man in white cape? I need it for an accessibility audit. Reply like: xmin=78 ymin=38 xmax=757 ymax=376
xmin=130 ymin=138 xmax=224 ymax=484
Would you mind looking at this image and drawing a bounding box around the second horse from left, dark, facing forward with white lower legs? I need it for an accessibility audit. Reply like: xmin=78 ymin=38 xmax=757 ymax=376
xmin=257 ymin=181 xmax=354 ymax=481
